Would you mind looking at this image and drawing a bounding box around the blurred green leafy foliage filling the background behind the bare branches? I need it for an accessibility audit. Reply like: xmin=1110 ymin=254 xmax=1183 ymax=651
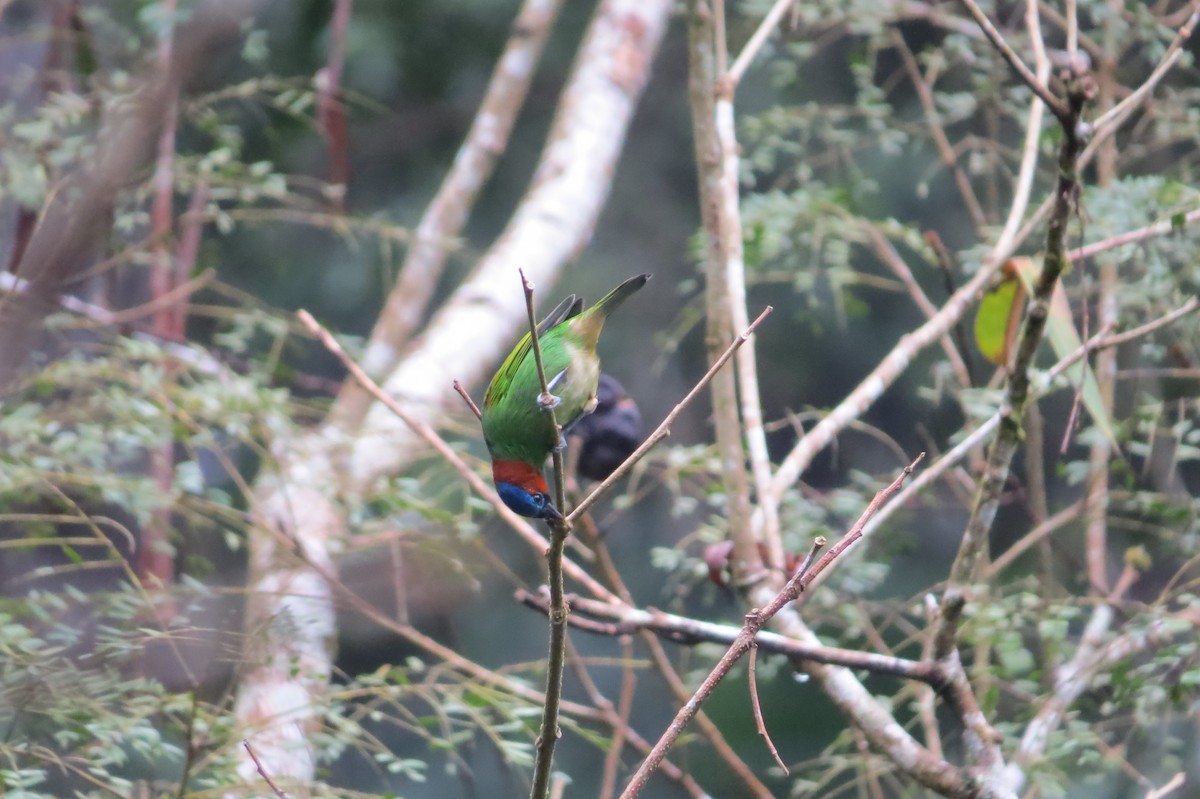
xmin=0 ymin=0 xmax=1200 ymax=798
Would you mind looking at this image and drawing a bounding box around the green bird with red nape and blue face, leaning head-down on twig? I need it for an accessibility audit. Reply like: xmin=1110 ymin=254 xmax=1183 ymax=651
xmin=480 ymin=275 xmax=650 ymax=521
